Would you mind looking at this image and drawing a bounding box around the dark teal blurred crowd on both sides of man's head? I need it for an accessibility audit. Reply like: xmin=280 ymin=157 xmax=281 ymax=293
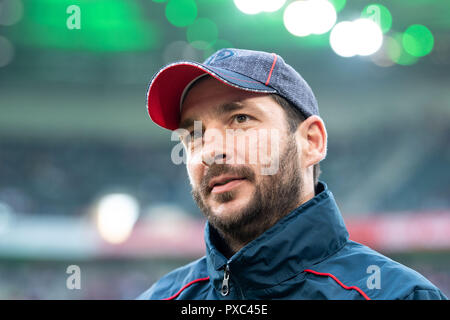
xmin=0 ymin=121 xmax=450 ymax=216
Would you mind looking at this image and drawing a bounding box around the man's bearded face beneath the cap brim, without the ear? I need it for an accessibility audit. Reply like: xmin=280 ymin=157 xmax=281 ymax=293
xmin=180 ymin=77 xmax=302 ymax=242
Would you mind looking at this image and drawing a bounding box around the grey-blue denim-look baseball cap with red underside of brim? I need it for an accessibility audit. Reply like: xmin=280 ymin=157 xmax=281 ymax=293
xmin=147 ymin=48 xmax=319 ymax=130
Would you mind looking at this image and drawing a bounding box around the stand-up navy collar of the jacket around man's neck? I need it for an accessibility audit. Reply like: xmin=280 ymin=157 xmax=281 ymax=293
xmin=205 ymin=182 xmax=348 ymax=291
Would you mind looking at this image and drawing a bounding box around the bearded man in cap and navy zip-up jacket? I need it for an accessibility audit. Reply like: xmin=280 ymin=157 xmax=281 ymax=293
xmin=139 ymin=49 xmax=446 ymax=300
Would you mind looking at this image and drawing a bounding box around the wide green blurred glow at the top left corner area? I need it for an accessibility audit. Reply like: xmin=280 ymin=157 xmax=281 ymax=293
xmin=15 ymin=0 xmax=159 ymax=52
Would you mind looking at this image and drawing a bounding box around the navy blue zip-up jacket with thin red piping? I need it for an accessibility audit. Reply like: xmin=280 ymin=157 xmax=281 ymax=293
xmin=138 ymin=182 xmax=447 ymax=300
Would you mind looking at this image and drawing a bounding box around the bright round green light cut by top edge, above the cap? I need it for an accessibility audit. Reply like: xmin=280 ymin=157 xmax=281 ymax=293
xmin=166 ymin=0 xmax=197 ymax=27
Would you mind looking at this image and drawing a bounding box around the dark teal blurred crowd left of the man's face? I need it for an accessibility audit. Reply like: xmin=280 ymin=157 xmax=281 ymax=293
xmin=0 ymin=140 xmax=199 ymax=215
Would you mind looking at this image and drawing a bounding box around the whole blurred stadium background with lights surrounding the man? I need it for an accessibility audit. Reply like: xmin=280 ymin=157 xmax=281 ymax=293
xmin=0 ymin=0 xmax=450 ymax=299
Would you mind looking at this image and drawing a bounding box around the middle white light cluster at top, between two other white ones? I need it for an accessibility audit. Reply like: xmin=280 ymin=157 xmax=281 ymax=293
xmin=283 ymin=0 xmax=336 ymax=37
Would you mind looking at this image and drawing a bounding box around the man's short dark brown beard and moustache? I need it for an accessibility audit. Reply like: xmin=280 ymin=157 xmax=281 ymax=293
xmin=192 ymin=137 xmax=303 ymax=244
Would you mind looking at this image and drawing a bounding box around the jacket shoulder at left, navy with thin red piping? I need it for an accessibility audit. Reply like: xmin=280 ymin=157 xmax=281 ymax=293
xmin=137 ymin=257 xmax=209 ymax=300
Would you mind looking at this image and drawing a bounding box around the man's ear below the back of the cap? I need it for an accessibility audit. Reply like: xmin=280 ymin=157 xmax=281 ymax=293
xmin=296 ymin=115 xmax=327 ymax=168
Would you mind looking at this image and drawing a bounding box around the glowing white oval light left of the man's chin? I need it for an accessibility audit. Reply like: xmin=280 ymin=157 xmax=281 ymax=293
xmin=97 ymin=193 xmax=139 ymax=244
